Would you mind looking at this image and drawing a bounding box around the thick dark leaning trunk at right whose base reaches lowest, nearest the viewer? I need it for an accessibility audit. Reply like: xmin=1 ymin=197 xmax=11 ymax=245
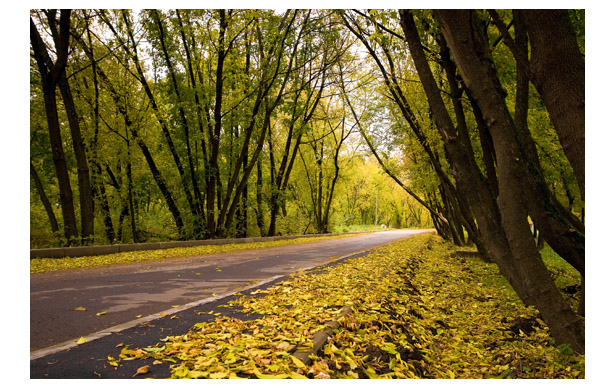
xmin=435 ymin=10 xmax=584 ymax=353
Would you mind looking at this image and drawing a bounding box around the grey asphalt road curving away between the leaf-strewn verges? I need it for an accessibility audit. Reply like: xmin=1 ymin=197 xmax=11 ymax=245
xmin=30 ymin=230 xmax=427 ymax=378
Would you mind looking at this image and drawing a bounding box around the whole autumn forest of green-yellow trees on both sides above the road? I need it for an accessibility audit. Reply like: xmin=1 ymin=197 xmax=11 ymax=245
xmin=30 ymin=9 xmax=585 ymax=353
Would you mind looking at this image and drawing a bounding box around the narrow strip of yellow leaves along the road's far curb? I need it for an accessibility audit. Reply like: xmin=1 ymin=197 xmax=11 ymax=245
xmin=30 ymin=233 xmax=360 ymax=274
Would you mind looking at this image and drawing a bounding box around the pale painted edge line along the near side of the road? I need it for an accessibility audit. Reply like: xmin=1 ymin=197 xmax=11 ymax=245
xmin=30 ymin=249 xmax=371 ymax=361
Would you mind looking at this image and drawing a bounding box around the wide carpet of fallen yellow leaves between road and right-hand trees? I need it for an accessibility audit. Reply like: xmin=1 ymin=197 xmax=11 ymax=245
xmin=114 ymin=235 xmax=584 ymax=378
